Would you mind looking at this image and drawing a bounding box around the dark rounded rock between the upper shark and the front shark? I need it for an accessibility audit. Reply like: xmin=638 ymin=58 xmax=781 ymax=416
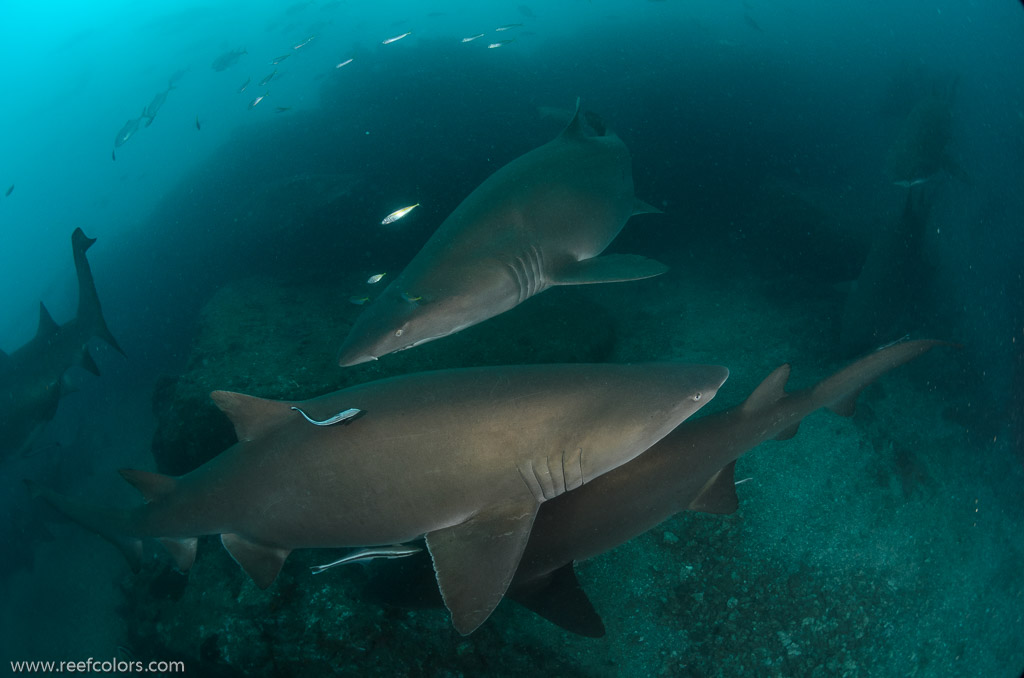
xmin=153 ymin=278 xmax=615 ymax=475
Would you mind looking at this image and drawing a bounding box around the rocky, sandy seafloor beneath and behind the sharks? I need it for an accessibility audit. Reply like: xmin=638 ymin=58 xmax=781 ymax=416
xmin=81 ymin=245 xmax=1024 ymax=676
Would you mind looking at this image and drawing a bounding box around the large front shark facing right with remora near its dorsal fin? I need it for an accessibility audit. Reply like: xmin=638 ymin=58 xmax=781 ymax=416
xmin=30 ymin=364 xmax=728 ymax=634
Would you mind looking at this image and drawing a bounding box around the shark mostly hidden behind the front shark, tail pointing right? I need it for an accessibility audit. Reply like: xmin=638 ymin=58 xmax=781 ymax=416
xmin=367 ymin=340 xmax=946 ymax=637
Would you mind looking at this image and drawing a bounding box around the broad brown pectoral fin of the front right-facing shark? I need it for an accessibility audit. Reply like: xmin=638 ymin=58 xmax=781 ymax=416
xmin=427 ymin=496 xmax=539 ymax=635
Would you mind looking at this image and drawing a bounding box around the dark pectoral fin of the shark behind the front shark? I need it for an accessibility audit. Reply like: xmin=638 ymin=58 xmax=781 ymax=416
xmin=509 ymin=562 xmax=604 ymax=638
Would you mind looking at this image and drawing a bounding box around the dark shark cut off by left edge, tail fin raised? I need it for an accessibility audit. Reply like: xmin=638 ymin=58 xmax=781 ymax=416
xmin=0 ymin=228 xmax=124 ymax=460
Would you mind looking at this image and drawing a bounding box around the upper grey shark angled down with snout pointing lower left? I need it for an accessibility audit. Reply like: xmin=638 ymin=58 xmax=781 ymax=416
xmin=338 ymin=102 xmax=667 ymax=366
